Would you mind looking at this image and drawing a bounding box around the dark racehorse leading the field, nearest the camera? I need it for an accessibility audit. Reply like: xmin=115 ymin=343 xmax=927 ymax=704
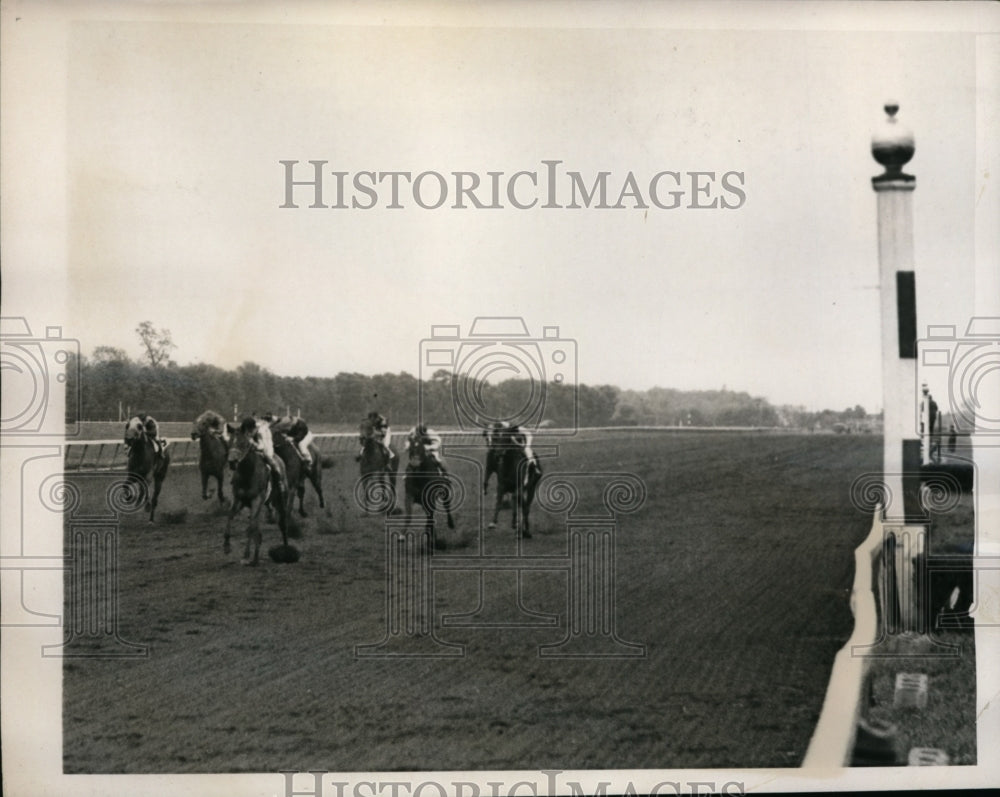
xmin=222 ymin=427 xmax=290 ymax=565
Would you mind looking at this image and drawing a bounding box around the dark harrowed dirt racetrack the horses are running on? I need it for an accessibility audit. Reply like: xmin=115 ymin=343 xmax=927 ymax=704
xmin=63 ymin=433 xmax=881 ymax=773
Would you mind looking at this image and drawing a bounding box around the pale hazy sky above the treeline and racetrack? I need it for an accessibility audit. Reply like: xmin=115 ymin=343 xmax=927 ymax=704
xmin=11 ymin=3 xmax=988 ymax=411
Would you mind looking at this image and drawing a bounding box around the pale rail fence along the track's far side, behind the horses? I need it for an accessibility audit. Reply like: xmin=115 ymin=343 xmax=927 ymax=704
xmin=64 ymin=426 xmax=802 ymax=471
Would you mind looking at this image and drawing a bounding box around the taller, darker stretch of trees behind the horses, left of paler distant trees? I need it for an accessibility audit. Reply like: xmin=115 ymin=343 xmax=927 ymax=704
xmin=68 ymin=347 xmax=619 ymax=427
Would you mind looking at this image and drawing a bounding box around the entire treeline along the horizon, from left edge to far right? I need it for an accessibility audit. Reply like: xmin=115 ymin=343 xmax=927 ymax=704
xmin=67 ymin=347 xmax=872 ymax=431
